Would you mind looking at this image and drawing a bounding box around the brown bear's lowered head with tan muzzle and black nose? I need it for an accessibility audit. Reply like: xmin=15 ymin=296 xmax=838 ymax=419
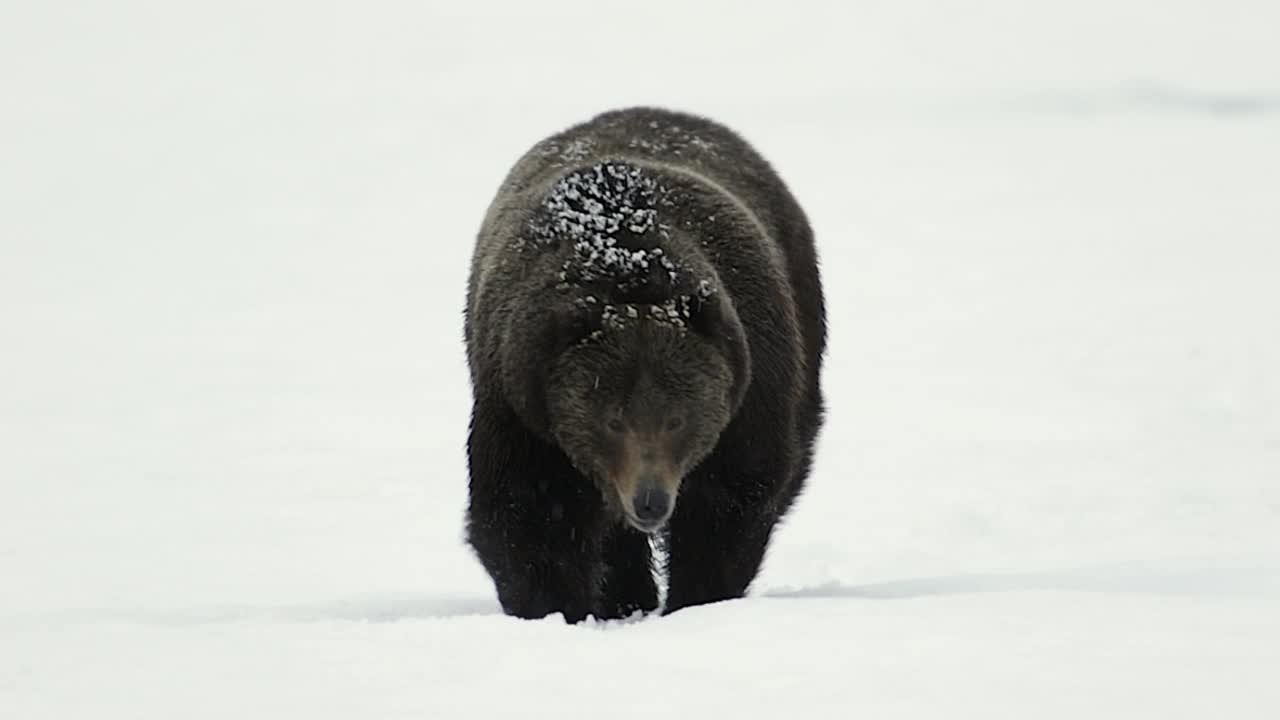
xmin=544 ymin=286 xmax=750 ymax=533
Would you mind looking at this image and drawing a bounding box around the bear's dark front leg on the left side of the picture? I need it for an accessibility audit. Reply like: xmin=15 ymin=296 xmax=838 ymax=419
xmin=467 ymin=394 xmax=604 ymax=623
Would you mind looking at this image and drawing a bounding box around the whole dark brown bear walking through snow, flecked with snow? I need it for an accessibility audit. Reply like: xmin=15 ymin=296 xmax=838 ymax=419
xmin=466 ymin=108 xmax=826 ymax=621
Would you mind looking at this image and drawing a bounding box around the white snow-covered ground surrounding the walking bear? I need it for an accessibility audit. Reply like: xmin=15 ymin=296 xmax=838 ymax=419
xmin=0 ymin=0 xmax=1280 ymax=719
